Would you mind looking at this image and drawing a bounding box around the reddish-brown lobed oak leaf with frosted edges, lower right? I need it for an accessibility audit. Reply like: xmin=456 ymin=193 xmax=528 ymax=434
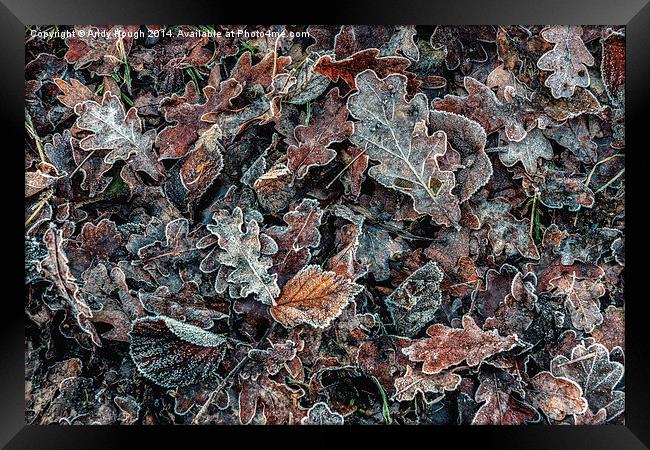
xmin=402 ymin=315 xmax=517 ymax=374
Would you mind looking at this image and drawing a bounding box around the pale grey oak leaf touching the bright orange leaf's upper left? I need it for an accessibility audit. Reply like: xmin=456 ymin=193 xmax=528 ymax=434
xmin=198 ymin=207 xmax=280 ymax=305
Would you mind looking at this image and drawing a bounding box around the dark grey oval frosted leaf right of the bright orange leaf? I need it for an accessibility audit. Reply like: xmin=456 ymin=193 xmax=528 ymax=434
xmin=386 ymin=261 xmax=443 ymax=337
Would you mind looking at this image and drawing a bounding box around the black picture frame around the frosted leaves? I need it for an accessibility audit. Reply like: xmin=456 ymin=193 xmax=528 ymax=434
xmin=0 ymin=0 xmax=650 ymax=450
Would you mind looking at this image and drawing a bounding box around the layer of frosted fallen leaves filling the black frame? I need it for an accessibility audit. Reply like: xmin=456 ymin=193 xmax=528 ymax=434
xmin=25 ymin=25 xmax=625 ymax=425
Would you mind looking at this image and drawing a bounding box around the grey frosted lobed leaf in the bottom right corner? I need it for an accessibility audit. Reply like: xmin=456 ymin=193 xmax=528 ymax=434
xmin=551 ymin=344 xmax=625 ymax=420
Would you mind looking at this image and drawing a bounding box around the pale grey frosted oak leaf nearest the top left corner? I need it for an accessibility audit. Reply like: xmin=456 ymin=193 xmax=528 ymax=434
xmin=74 ymin=91 xmax=163 ymax=180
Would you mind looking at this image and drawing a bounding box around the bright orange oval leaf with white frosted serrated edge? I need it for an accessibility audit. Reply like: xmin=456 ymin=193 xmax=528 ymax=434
xmin=271 ymin=265 xmax=363 ymax=328
